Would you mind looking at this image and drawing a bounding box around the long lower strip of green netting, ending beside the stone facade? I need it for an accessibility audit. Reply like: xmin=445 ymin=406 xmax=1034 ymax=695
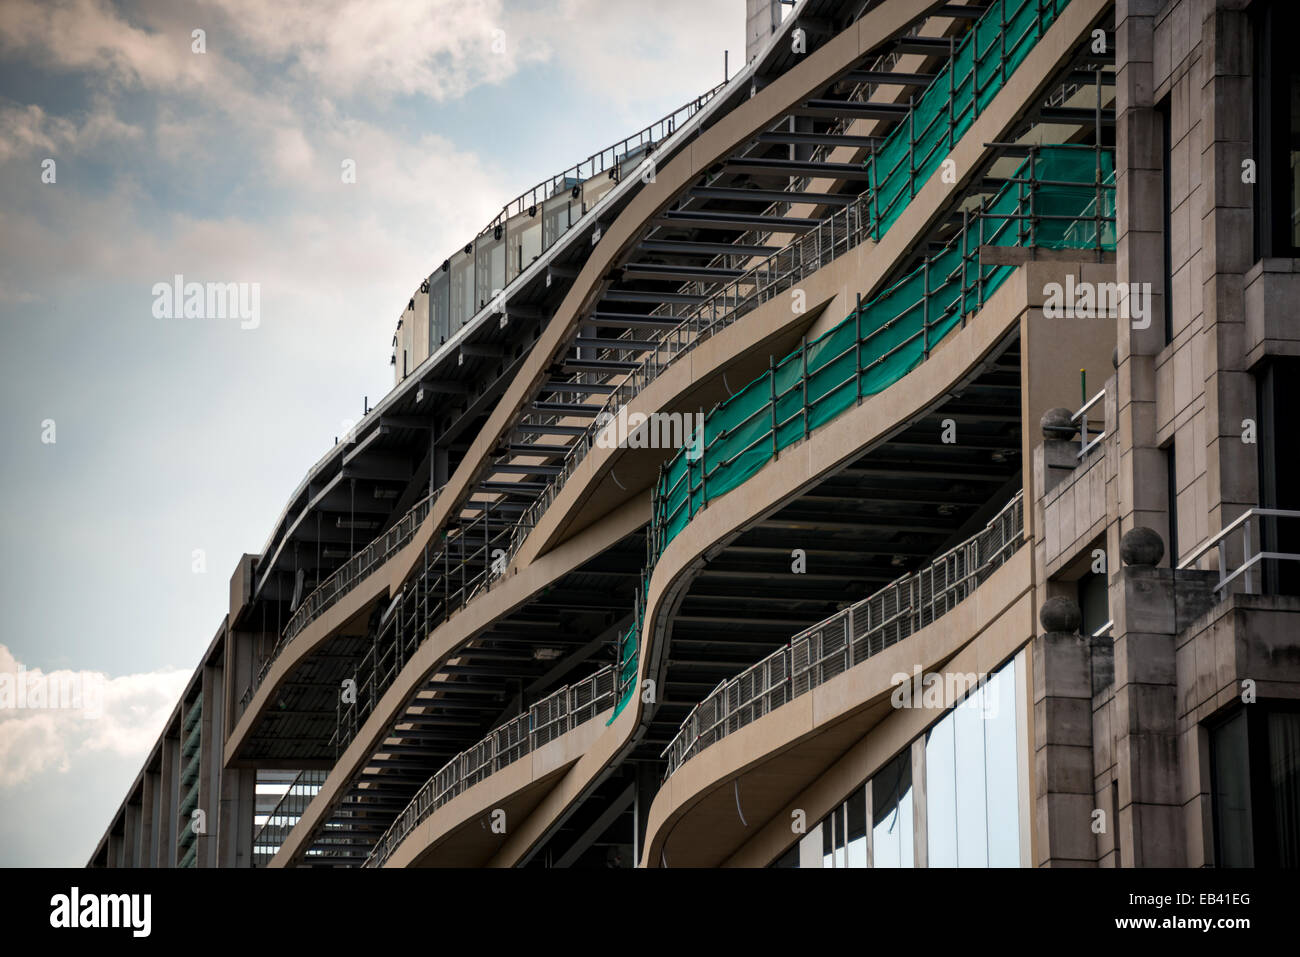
xmin=655 ymin=147 xmax=1114 ymax=551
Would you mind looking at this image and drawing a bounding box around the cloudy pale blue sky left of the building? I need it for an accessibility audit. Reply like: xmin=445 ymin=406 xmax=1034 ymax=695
xmin=0 ymin=0 xmax=745 ymax=866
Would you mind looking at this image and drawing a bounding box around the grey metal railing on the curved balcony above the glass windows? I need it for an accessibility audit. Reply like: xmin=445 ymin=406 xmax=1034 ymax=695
xmin=663 ymin=492 xmax=1024 ymax=779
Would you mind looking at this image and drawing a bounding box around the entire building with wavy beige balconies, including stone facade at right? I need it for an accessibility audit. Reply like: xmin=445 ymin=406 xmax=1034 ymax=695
xmin=90 ymin=0 xmax=1300 ymax=867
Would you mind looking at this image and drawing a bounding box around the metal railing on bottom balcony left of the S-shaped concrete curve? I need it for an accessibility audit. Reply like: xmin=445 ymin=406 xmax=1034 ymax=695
xmin=365 ymin=664 xmax=615 ymax=867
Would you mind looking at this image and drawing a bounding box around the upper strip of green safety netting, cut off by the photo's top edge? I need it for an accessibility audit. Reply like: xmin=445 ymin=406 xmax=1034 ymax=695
xmin=868 ymin=0 xmax=1070 ymax=238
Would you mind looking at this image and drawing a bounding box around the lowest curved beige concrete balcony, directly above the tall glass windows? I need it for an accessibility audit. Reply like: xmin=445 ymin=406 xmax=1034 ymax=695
xmin=640 ymin=538 xmax=1036 ymax=867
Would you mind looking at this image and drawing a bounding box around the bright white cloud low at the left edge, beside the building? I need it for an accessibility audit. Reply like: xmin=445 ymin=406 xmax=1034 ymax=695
xmin=0 ymin=645 xmax=190 ymax=791
